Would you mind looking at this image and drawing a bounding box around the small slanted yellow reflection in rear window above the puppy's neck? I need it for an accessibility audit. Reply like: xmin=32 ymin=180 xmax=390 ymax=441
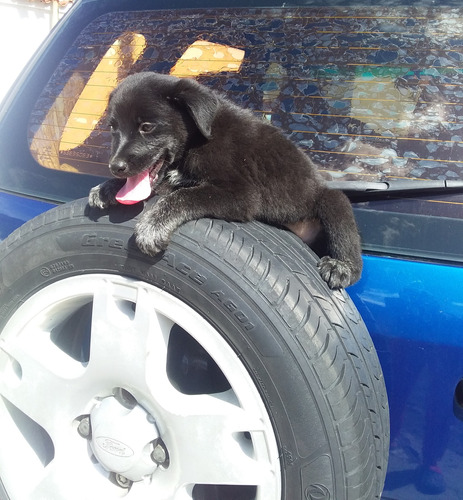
xmin=170 ymin=40 xmax=244 ymax=78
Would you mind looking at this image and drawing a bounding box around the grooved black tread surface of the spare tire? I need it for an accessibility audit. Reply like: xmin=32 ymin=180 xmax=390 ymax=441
xmin=178 ymin=220 xmax=389 ymax=500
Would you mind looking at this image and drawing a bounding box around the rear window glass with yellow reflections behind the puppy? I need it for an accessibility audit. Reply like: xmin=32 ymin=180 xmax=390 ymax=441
xmin=28 ymin=7 xmax=463 ymax=184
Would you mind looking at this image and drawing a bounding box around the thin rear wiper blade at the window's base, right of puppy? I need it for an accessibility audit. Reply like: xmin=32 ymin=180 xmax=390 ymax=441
xmin=327 ymin=179 xmax=463 ymax=196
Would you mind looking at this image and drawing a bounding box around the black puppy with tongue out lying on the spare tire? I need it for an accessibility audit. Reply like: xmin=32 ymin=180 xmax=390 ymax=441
xmin=89 ymin=73 xmax=362 ymax=288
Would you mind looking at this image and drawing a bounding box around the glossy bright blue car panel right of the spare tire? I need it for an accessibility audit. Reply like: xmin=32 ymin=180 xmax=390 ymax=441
xmin=348 ymin=256 xmax=463 ymax=500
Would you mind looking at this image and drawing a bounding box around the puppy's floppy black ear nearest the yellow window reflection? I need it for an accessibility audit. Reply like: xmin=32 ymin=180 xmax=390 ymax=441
xmin=172 ymin=78 xmax=219 ymax=139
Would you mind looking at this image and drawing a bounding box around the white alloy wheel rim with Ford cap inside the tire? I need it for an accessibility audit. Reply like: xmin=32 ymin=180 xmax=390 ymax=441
xmin=0 ymin=274 xmax=281 ymax=500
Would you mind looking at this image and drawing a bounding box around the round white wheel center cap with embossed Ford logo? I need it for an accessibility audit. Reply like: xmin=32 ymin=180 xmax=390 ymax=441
xmin=90 ymin=396 xmax=159 ymax=481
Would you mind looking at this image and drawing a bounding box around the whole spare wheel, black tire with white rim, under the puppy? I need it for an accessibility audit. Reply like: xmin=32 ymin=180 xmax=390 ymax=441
xmin=0 ymin=200 xmax=389 ymax=500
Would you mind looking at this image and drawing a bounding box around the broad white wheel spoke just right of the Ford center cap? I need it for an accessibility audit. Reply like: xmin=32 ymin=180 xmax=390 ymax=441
xmin=161 ymin=395 xmax=272 ymax=485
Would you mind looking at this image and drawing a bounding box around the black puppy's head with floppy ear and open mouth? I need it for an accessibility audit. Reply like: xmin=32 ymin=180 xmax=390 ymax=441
xmin=108 ymin=72 xmax=219 ymax=186
